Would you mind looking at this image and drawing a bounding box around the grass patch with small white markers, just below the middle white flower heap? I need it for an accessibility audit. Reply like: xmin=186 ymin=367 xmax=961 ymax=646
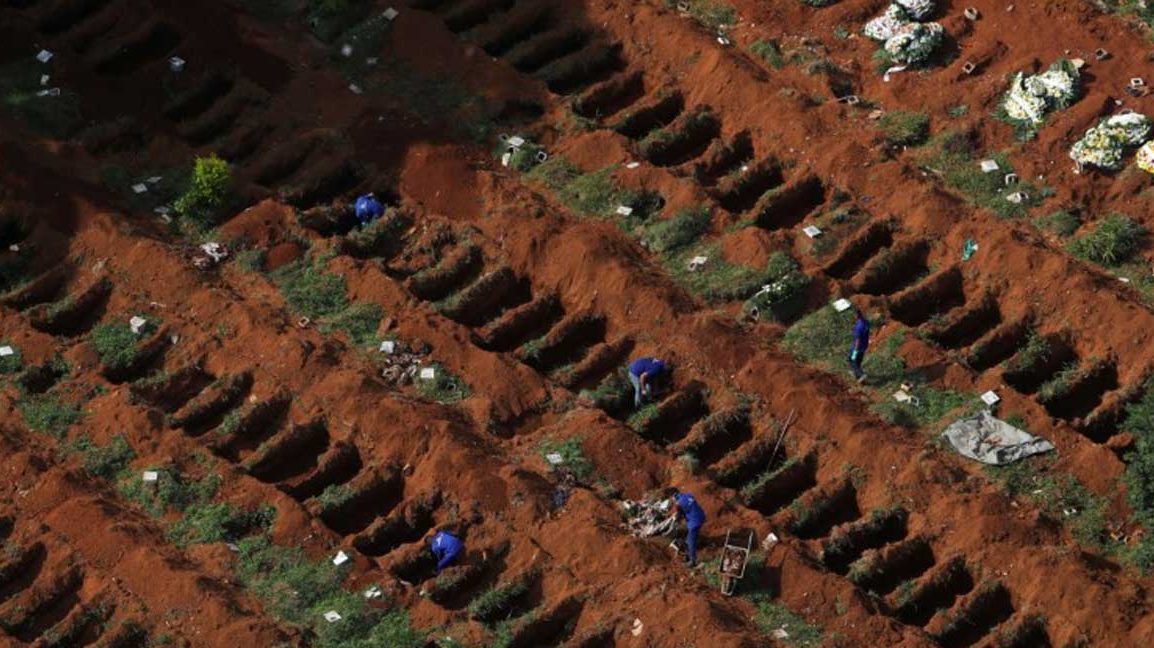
xmin=919 ymin=133 xmax=1039 ymax=218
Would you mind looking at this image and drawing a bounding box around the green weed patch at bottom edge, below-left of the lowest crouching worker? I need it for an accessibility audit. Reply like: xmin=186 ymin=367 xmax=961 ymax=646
xmin=237 ymin=536 xmax=425 ymax=648
